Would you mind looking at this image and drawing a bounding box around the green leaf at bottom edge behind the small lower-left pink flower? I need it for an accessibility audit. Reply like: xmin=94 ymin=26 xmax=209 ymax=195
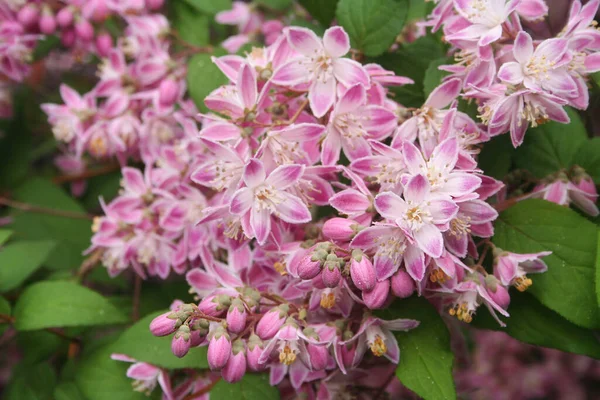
xmin=75 ymin=345 xmax=149 ymax=400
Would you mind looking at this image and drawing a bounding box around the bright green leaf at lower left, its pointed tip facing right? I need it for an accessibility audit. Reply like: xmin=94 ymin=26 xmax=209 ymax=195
xmin=14 ymin=281 xmax=128 ymax=331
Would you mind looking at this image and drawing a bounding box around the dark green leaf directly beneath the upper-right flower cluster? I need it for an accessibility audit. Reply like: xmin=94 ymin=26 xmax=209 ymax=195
xmin=514 ymin=107 xmax=587 ymax=178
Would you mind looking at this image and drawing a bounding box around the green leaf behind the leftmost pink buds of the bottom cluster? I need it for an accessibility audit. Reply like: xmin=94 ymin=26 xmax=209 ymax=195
xmin=113 ymin=310 xmax=208 ymax=368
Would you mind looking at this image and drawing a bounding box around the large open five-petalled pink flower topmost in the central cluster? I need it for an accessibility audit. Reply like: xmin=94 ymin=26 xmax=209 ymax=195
xmin=271 ymin=26 xmax=369 ymax=117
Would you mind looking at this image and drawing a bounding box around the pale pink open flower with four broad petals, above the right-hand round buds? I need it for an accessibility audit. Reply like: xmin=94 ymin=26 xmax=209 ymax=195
xmin=375 ymin=175 xmax=458 ymax=257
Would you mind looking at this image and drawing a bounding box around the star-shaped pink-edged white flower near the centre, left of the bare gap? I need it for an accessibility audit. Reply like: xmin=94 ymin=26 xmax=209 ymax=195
xmin=229 ymin=158 xmax=312 ymax=244
